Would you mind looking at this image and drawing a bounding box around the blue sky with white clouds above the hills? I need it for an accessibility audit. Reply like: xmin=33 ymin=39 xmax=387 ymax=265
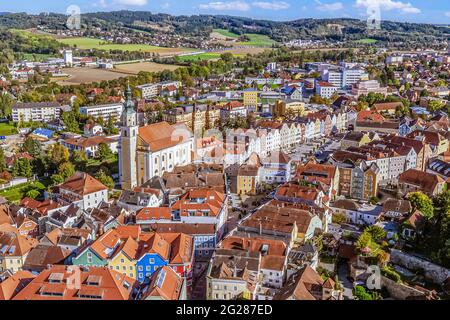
xmin=0 ymin=0 xmax=450 ymax=24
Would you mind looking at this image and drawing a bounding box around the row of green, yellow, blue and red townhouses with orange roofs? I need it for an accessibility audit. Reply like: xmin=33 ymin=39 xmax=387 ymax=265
xmin=72 ymin=225 xmax=194 ymax=285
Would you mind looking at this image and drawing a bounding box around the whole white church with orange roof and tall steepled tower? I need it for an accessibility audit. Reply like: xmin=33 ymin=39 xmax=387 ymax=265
xmin=118 ymin=87 xmax=194 ymax=190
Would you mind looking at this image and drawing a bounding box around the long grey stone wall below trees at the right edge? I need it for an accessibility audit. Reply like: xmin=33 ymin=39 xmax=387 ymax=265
xmin=390 ymin=249 xmax=450 ymax=284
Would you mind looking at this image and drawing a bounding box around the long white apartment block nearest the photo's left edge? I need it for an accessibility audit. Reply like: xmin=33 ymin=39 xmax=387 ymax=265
xmin=12 ymin=102 xmax=61 ymax=122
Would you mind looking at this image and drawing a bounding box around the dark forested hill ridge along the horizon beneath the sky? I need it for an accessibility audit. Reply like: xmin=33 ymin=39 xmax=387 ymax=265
xmin=0 ymin=10 xmax=450 ymax=42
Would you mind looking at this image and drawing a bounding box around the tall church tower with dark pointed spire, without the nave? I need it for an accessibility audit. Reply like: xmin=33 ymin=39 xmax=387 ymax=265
xmin=119 ymin=85 xmax=139 ymax=190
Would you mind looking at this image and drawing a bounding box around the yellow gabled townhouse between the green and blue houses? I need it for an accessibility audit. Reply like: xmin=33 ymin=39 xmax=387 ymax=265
xmin=108 ymin=238 xmax=139 ymax=279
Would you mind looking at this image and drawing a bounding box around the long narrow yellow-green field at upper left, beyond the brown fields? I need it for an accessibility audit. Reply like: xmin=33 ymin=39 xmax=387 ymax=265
xmin=57 ymin=38 xmax=192 ymax=55
